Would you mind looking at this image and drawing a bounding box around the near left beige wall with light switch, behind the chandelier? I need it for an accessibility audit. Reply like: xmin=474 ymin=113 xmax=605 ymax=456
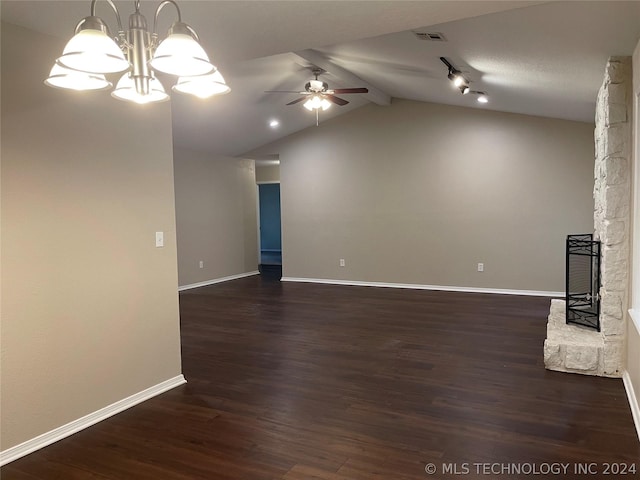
xmin=0 ymin=23 xmax=181 ymax=450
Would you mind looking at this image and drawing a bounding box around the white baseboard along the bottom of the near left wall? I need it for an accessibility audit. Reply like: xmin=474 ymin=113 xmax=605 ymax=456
xmin=0 ymin=375 xmax=187 ymax=466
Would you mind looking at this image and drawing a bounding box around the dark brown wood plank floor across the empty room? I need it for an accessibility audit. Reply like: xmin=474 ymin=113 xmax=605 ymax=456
xmin=1 ymin=276 xmax=640 ymax=480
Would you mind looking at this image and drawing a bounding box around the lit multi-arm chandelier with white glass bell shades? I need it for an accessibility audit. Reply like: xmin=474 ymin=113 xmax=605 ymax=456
xmin=45 ymin=0 xmax=231 ymax=104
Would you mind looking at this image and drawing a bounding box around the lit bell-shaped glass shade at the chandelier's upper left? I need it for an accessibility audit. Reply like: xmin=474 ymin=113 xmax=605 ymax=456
xmin=57 ymin=29 xmax=130 ymax=74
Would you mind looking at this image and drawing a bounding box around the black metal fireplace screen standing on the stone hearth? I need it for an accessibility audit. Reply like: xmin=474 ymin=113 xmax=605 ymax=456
xmin=565 ymin=234 xmax=600 ymax=331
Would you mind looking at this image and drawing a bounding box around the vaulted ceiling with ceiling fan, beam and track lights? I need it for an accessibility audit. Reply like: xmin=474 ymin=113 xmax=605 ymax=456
xmin=0 ymin=0 xmax=640 ymax=156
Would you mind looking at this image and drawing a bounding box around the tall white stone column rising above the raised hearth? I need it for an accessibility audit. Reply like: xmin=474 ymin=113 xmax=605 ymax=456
xmin=593 ymin=57 xmax=632 ymax=376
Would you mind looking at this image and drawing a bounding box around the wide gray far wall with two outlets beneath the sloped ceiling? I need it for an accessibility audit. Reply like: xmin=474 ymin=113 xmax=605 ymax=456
xmin=251 ymin=100 xmax=594 ymax=291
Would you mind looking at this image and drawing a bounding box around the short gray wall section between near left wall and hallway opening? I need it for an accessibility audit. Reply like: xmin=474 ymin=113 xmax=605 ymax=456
xmin=174 ymin=149 xmax=258 ymax=286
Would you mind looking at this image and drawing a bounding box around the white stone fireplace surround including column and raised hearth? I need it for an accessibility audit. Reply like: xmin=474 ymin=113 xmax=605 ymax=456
xmin=544 ymin=57 xmax=632 ymax=377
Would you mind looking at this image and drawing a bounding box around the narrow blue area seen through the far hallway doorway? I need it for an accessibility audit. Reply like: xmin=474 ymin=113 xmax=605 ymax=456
xmin=258 ymin=183 xmax=282 ymax=265
